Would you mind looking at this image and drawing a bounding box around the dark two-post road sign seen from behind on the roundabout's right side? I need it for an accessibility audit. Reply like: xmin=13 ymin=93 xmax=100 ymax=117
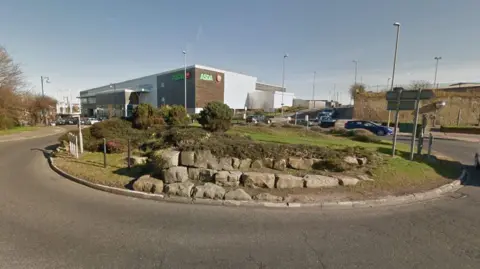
xmin=386 ymin=87 xmax=434 ymax=160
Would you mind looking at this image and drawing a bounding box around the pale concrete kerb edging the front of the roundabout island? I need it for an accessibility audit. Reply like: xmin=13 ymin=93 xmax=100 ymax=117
xmin=48 ymin=156 xmax=467 ymax=209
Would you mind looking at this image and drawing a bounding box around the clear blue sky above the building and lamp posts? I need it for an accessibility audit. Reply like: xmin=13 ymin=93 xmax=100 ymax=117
xmin=0 ymin=0 xmax=480 ymax=103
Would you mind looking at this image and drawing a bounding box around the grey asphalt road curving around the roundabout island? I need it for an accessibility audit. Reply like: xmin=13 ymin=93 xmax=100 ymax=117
xmin=0 ymin=133 xmax=480 ymax=269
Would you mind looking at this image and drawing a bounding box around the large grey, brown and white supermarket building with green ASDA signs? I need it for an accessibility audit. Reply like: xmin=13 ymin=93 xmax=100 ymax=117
xmin=79 ymin=65 xmax=294 ymax=117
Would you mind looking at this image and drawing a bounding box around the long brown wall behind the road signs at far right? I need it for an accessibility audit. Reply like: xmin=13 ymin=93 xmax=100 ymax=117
xmin=353 ymin=88 xmax=480 ymax=125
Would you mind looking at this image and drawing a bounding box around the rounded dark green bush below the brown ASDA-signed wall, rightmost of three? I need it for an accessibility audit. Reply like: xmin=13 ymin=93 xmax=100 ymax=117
xmin=198 ymin=101 xmax=233 ymax=132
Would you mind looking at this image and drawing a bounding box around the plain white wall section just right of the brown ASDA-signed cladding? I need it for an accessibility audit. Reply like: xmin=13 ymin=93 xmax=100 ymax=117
xmin=224 ymin=71 xmax=257 ymax=109
